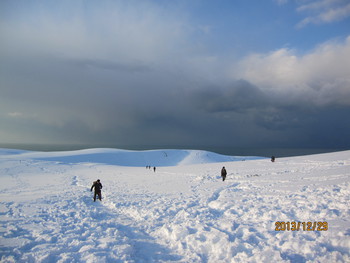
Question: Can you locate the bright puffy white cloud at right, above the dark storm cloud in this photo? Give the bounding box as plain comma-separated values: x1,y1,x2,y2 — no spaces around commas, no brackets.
232,37,350,106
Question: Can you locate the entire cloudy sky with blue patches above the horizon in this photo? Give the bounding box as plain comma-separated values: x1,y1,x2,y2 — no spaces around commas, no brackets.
0,0,350,151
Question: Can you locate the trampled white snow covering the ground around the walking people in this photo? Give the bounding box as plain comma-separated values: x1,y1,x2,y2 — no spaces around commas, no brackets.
0,149,350,262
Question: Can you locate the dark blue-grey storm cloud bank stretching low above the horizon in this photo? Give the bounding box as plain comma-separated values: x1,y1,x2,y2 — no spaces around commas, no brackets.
0,45,350,150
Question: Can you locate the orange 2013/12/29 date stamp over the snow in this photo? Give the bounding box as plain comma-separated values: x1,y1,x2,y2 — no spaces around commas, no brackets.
275,221,328,231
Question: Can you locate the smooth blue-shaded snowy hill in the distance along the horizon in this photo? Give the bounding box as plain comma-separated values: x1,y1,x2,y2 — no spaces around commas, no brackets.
0,149,262,167
